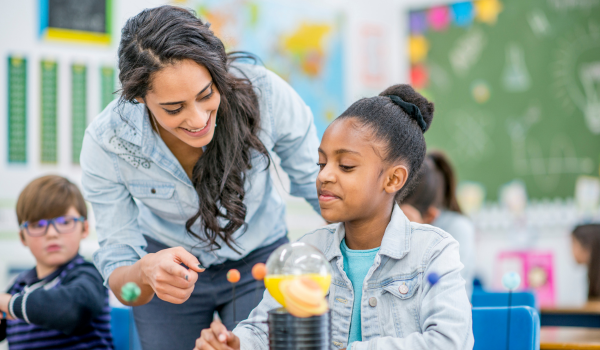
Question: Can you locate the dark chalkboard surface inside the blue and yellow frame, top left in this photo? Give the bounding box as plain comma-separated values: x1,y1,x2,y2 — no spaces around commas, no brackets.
48,0,107,33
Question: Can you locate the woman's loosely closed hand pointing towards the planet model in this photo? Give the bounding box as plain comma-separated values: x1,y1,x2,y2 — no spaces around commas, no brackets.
140,247,204,304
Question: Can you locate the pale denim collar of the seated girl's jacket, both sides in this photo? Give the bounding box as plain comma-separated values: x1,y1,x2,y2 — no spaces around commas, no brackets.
325,204,411,261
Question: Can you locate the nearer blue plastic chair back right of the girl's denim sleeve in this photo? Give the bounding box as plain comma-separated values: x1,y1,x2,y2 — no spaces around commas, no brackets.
473,306,540,350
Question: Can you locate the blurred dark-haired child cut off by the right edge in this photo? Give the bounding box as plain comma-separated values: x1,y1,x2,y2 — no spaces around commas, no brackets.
572,224,600,301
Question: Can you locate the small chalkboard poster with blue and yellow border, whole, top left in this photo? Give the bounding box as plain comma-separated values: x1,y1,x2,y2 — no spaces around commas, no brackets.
39,0,113,45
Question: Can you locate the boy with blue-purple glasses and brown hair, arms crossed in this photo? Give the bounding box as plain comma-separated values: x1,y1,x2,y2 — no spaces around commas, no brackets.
0,175,113,349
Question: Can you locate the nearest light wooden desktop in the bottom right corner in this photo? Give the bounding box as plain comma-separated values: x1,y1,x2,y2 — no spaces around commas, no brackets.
540,327,600,350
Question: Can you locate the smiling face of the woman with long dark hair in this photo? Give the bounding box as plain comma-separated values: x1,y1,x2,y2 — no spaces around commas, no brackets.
137,60,221,148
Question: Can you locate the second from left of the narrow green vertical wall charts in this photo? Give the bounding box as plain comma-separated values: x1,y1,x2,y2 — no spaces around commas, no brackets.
40,60,58,164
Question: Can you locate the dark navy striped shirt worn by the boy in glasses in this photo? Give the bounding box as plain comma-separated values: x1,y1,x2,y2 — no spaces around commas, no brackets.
0,255,113,350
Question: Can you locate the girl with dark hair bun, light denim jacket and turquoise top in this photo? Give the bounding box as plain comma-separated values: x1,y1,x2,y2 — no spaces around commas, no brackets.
196,85,473,350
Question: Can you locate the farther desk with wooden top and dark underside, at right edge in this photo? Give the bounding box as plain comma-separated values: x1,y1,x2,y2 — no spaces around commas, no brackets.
540,301,600,328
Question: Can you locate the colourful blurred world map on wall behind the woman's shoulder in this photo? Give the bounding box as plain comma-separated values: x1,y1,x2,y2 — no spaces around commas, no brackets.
175,0,345,137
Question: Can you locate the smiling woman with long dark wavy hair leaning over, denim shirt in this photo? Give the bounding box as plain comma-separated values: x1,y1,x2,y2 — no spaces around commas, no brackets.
81,6,319,350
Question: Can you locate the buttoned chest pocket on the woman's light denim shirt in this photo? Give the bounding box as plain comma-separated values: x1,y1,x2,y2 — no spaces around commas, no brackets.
127,181,183,220
